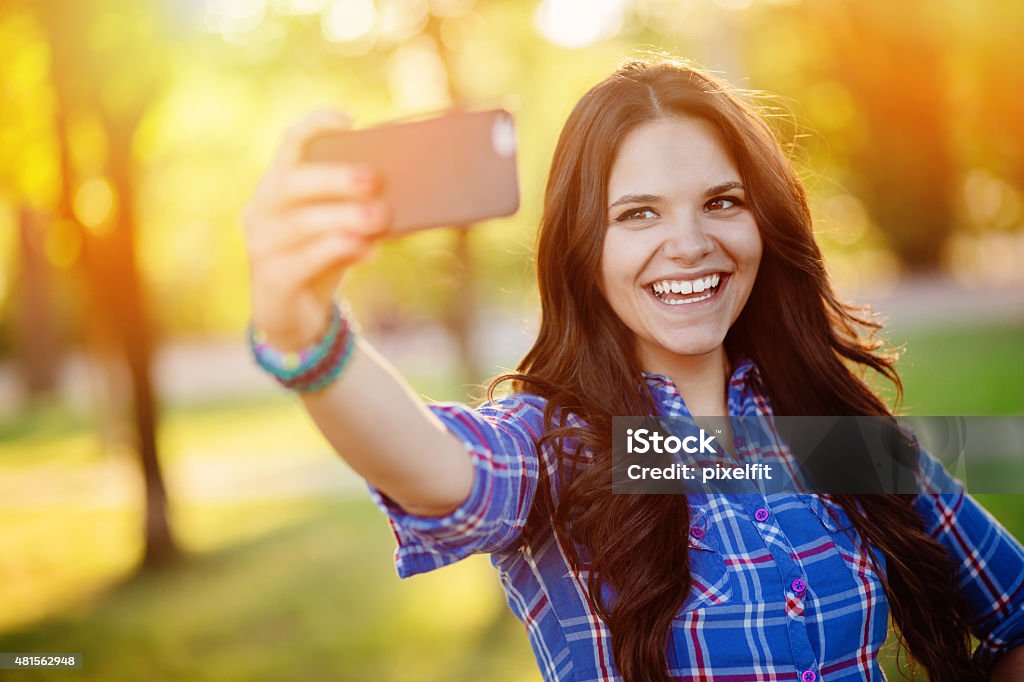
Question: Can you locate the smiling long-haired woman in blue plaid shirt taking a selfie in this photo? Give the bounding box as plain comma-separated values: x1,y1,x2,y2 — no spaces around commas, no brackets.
245,58,1024,682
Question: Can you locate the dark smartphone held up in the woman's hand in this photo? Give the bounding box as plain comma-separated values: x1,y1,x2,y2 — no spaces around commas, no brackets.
305,110,519,233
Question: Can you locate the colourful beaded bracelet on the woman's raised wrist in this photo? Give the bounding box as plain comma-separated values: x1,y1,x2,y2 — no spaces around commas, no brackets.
249,303,355,393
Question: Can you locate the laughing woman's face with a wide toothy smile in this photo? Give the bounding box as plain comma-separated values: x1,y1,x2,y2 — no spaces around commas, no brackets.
601,118,761,372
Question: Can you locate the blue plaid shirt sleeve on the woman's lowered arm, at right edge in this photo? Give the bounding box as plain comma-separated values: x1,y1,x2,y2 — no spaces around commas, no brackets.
916,449,1024,670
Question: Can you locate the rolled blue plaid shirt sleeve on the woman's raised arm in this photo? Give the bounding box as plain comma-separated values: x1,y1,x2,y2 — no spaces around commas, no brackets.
368,396,544,578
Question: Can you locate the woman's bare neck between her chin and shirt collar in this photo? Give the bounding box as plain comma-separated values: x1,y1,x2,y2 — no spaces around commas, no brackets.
641,346,729,417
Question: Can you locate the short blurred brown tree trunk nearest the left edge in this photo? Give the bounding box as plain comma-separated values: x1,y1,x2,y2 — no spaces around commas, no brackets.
14,206,60,402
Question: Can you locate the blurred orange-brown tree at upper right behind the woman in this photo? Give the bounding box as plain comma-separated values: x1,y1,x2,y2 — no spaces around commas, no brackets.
808,0,957,271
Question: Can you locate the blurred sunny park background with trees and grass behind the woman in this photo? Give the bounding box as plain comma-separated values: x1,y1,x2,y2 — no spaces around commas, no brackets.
0,0,1024,682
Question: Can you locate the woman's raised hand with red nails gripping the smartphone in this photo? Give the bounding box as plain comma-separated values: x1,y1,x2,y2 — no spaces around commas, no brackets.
243,111,390,350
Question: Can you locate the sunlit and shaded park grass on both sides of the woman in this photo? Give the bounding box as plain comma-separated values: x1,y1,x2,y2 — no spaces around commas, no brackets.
0,326,1024,682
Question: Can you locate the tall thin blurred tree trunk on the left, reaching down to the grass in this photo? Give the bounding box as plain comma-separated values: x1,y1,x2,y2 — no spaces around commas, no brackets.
36,0,180,567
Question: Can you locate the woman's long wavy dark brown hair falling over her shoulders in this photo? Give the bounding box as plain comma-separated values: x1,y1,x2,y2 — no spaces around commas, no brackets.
488,57,982,682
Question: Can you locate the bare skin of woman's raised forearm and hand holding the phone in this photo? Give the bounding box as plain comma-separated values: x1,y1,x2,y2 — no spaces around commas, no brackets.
243,111,473,516
